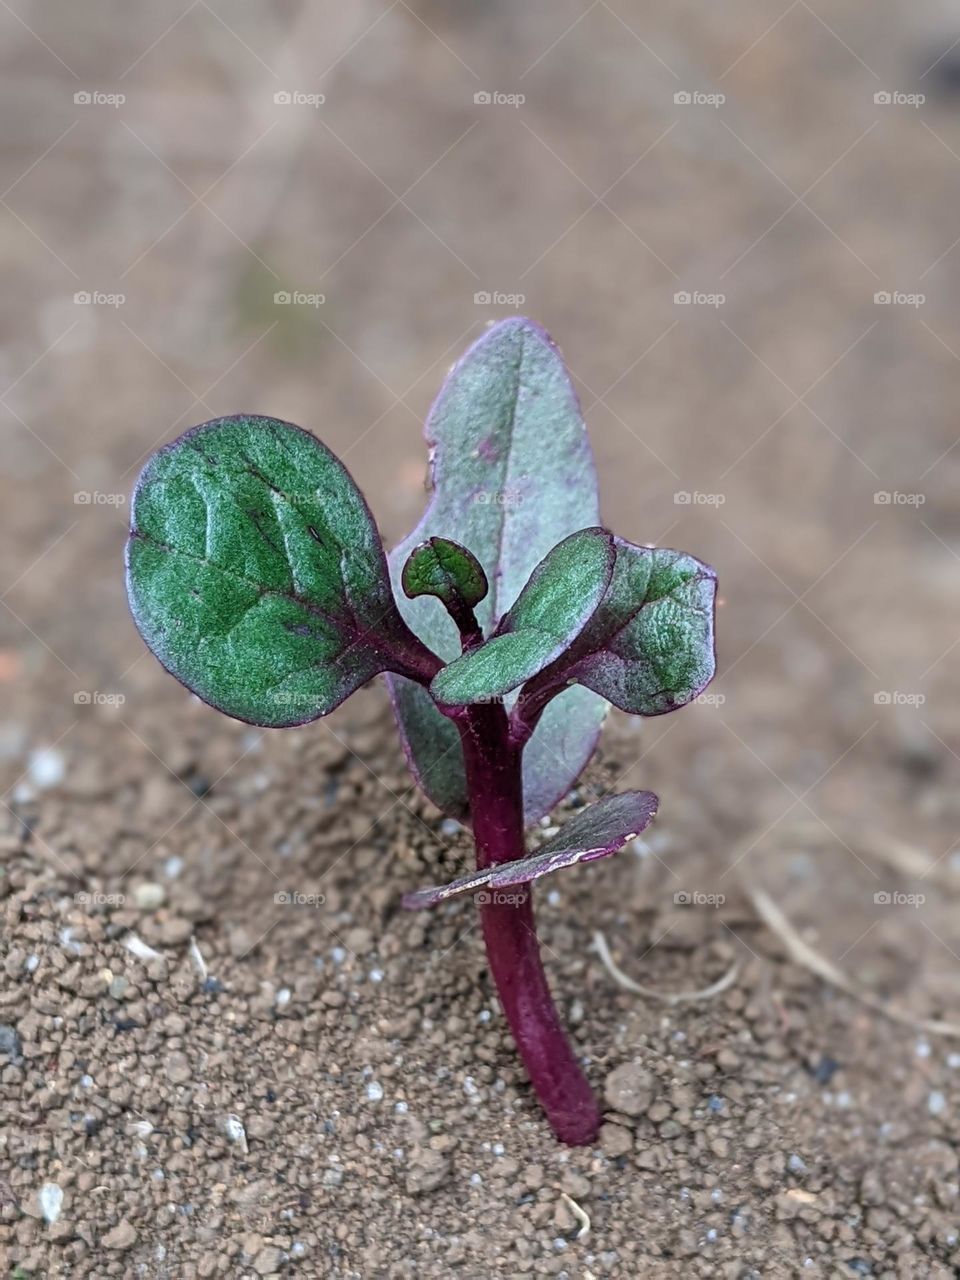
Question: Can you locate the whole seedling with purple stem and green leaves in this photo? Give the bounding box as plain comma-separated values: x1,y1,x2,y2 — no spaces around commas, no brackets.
127,319,717,1144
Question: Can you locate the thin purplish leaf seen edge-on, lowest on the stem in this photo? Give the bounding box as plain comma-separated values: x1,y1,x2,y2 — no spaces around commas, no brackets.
403,791,658,911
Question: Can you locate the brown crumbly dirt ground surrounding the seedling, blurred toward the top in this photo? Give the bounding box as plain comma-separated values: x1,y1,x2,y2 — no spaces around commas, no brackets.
0,0,960,1280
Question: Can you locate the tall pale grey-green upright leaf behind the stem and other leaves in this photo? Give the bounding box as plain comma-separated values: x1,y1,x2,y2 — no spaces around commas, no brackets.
387,317,607,823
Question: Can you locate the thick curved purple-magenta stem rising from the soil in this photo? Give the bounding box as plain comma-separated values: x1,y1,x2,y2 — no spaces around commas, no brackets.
457,704,600,1147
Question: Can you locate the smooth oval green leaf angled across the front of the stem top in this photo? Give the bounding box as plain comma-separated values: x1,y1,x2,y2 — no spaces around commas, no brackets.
430,529,614,707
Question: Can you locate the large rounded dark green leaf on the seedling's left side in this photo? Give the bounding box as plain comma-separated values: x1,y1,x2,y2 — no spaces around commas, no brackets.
127,416,436,726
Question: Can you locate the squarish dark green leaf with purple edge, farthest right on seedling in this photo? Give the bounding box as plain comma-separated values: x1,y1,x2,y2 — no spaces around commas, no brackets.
524,538,717,716
